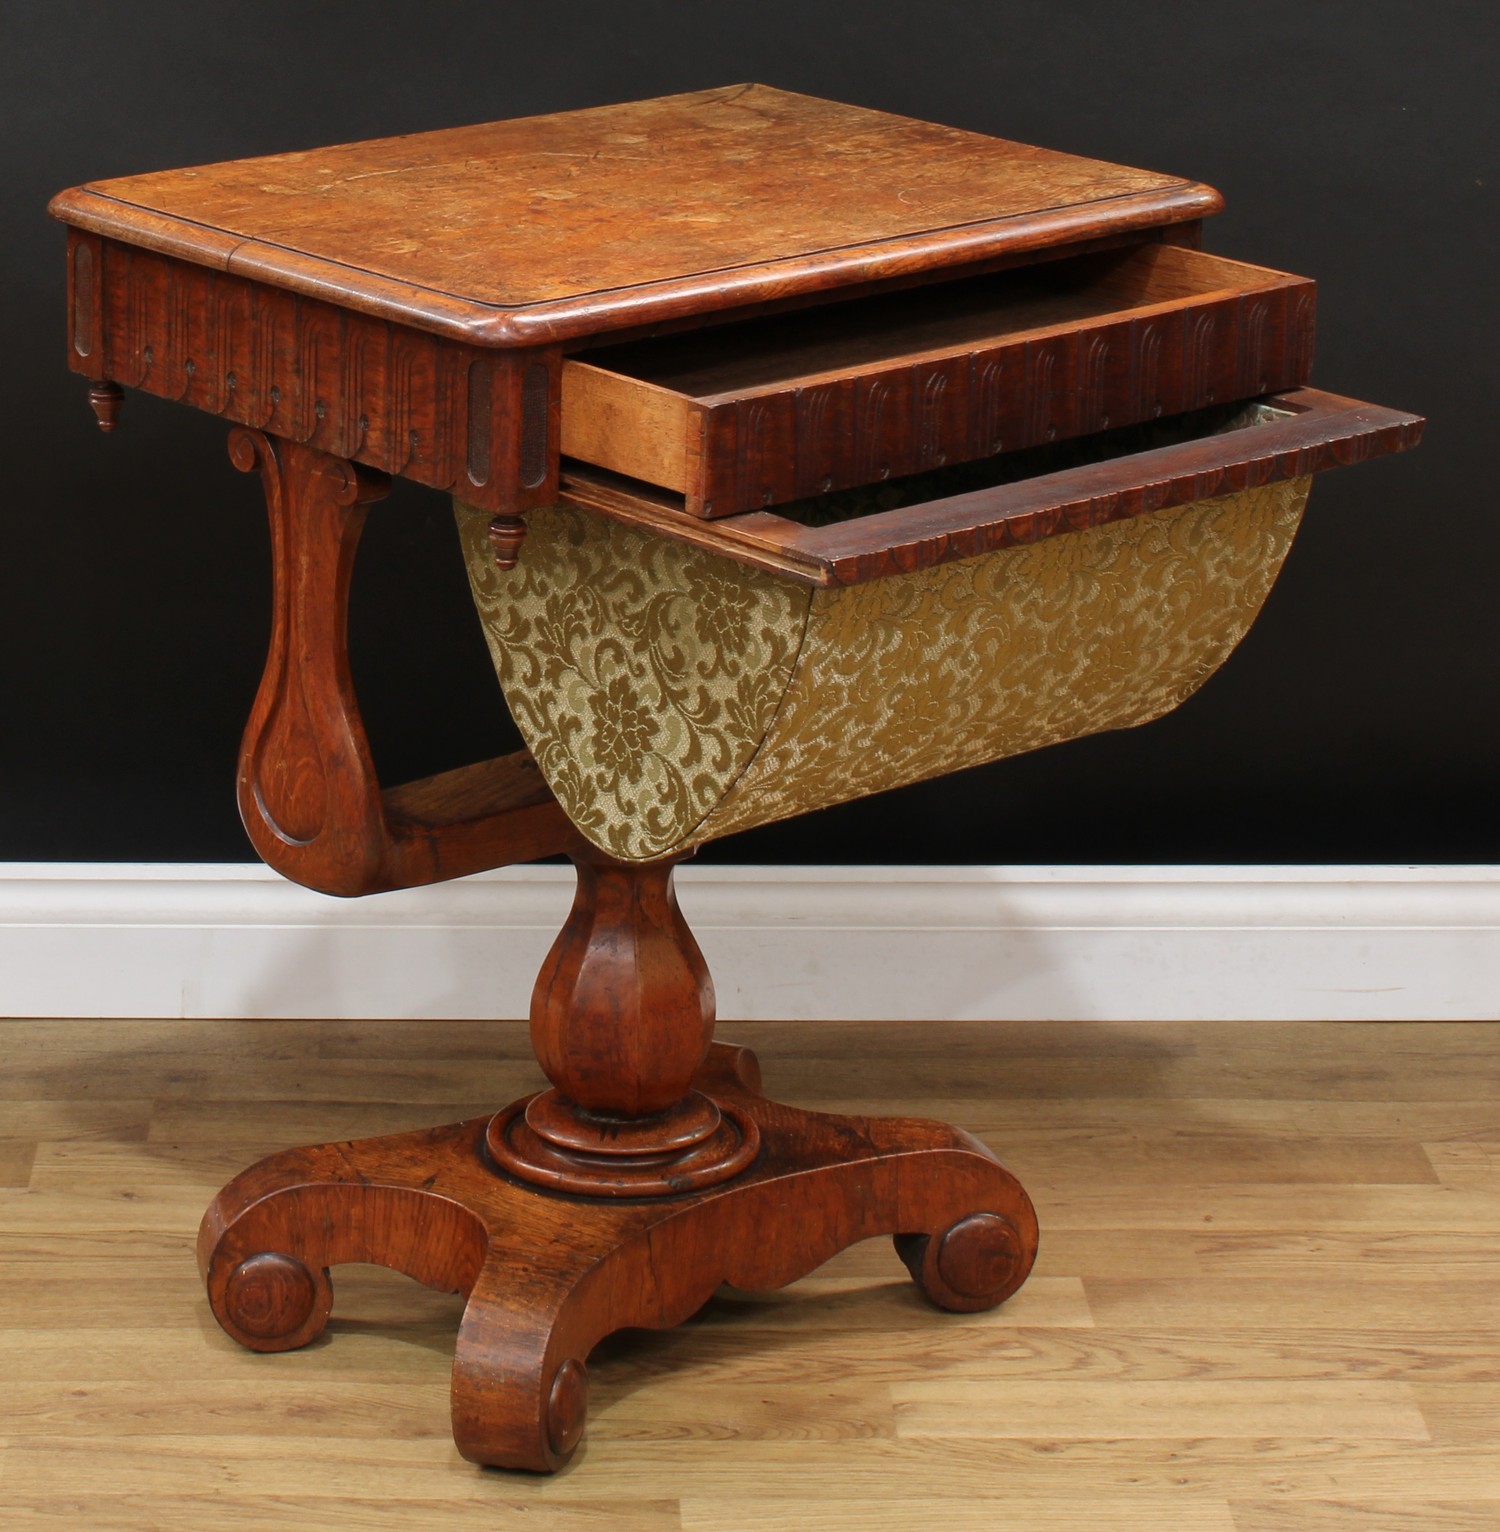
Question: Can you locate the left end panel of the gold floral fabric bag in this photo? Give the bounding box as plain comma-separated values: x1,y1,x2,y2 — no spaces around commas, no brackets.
457,504,811,859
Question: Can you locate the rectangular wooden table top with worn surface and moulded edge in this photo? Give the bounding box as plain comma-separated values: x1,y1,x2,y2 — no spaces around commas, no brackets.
52,84,1220,346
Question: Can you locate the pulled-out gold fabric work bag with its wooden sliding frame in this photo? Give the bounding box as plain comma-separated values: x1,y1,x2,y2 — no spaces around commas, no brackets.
458,391,1417,861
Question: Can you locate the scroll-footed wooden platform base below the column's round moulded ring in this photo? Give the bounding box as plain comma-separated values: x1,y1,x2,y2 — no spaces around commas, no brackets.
198,1043,1037,1471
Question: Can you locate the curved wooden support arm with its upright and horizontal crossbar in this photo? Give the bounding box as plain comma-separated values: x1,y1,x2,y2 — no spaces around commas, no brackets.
230,427,582,895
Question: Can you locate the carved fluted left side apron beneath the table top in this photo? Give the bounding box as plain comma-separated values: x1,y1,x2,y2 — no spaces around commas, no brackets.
58,230,562,513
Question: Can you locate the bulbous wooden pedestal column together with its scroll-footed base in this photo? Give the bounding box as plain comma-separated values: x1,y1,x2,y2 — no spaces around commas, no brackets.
199,856,1037,1471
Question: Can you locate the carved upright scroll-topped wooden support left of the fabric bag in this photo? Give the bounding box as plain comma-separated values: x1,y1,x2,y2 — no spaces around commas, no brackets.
230,427,389,895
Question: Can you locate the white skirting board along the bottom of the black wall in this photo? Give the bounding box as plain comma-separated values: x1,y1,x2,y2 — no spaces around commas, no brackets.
0,863,1500,1020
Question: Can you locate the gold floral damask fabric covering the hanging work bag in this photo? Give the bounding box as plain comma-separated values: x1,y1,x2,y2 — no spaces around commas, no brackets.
457,478,1310,861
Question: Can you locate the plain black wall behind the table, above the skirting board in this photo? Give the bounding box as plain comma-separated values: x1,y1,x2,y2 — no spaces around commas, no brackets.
0,0,1500,863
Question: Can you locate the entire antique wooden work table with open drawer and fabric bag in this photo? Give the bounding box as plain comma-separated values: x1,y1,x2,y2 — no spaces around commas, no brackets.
52,86,1420,1469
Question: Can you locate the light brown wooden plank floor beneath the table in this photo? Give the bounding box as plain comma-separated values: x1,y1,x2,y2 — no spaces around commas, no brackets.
0,1022,1500,1532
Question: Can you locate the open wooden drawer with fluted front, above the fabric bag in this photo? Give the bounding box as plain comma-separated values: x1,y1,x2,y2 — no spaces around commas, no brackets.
562,242,1315,518
